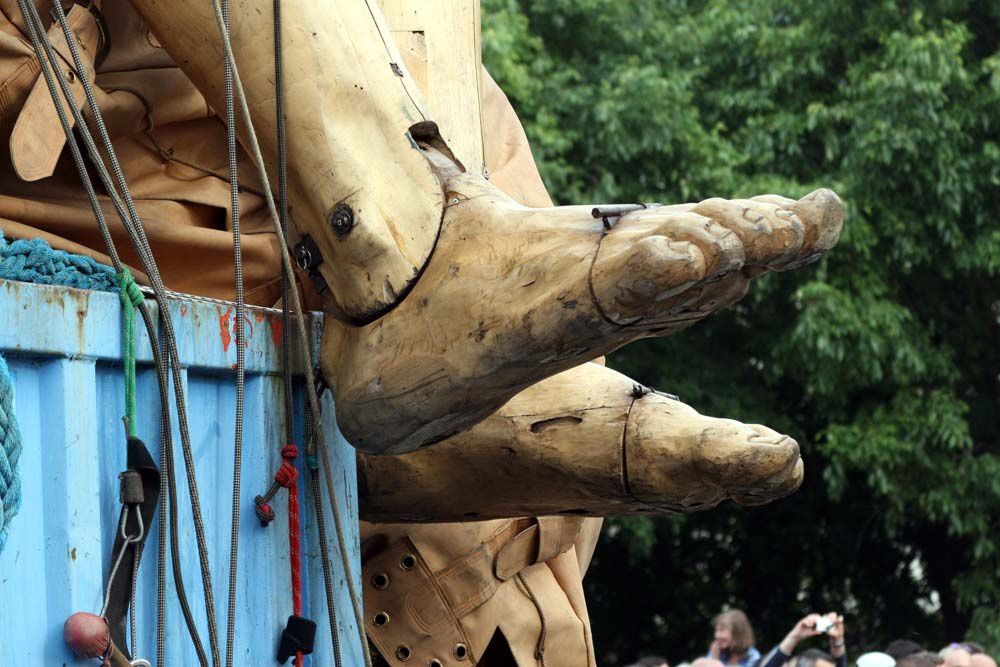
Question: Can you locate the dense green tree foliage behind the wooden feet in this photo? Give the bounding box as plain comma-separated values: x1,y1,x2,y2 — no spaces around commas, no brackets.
483,0,1000,664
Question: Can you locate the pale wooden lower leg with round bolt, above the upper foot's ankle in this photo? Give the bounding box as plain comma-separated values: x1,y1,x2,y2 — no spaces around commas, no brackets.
132,0,444,321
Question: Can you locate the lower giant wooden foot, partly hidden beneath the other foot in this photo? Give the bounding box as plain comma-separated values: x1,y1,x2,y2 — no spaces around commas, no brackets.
358,364,803,522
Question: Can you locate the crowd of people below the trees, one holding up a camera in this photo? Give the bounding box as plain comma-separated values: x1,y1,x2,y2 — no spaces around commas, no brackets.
627,609,997,667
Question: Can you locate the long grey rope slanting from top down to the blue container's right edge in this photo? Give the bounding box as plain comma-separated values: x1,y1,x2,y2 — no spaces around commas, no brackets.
212,0,372,667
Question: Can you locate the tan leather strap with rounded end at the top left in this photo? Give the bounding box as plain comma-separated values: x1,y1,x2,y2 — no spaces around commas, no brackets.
10,4,101,181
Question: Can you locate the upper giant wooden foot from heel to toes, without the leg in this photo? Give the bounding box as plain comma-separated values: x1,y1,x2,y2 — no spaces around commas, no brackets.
323,160,843,453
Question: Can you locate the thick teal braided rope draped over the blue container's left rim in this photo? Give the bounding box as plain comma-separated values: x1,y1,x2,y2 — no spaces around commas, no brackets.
0,230,119,552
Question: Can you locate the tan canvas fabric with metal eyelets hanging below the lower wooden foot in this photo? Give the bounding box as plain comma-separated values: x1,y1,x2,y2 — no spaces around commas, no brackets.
362,517,601,667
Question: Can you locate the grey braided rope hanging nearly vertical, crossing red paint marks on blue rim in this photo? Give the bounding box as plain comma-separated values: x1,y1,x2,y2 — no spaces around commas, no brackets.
222,0,248,667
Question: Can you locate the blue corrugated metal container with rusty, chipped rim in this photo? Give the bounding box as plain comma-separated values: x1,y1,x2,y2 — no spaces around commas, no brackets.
0,280,362,666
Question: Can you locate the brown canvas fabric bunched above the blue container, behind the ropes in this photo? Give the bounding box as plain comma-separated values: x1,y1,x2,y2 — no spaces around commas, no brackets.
0,0,280,305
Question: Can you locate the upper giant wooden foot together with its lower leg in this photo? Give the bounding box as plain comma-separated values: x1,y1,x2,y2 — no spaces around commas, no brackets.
133,0,842,453
